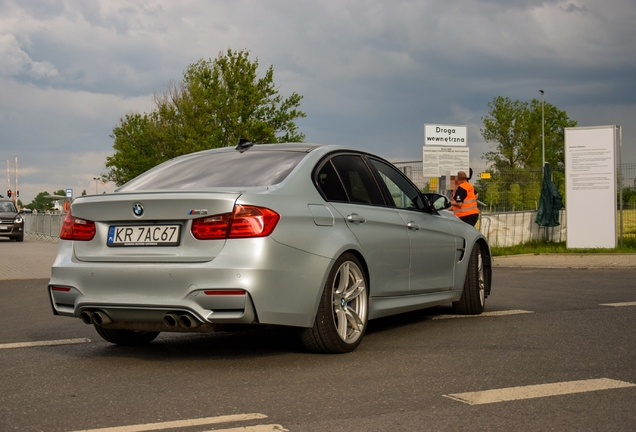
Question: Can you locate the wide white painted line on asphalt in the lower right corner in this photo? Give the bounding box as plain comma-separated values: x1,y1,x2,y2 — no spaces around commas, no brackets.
443,378,636,405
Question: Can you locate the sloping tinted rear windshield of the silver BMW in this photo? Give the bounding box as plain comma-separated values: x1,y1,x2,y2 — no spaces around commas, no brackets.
118,150,307,192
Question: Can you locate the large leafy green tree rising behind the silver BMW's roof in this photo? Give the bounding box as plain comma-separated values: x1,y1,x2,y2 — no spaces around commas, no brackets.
105,50,306,186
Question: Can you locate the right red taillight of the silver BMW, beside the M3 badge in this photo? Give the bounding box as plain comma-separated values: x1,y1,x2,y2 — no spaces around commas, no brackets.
191,205,280,240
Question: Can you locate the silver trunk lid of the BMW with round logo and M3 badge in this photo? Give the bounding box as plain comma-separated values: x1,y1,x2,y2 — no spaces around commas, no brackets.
71,192,241,262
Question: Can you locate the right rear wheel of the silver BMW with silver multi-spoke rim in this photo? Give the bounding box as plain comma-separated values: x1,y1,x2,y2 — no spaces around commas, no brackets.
300,253,369,354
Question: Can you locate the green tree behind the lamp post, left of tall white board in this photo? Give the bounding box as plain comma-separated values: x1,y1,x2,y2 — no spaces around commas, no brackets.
481,96,577,171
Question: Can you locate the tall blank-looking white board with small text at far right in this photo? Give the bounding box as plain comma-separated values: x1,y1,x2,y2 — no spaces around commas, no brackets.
565,126,617,248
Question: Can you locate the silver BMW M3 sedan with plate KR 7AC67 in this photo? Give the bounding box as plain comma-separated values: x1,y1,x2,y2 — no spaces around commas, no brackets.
48,143,492,353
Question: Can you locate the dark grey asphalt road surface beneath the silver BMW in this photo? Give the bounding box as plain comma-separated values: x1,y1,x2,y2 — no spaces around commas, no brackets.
0,239,636,432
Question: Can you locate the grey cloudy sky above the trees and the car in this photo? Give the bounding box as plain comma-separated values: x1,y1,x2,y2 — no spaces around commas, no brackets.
0,0,636,204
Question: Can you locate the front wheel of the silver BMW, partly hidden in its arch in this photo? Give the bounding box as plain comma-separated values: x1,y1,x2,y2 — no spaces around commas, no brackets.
453,243,486,315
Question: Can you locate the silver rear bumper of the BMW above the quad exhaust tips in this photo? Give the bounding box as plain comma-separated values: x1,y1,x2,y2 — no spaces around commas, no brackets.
48,237,332,331
